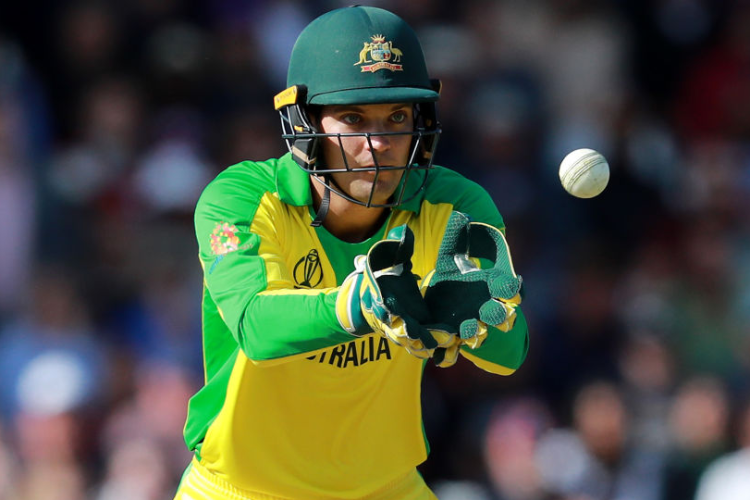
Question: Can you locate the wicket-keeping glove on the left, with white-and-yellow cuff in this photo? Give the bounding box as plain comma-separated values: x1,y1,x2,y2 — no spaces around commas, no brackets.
336,224,454,359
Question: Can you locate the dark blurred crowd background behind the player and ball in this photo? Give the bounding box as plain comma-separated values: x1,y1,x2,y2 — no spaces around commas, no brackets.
0,0,750,500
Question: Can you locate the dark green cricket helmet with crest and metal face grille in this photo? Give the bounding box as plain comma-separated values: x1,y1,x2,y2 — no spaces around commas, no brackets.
274,6,440,219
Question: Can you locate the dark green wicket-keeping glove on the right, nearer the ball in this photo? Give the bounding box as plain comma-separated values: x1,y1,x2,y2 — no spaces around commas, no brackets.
422,212,522,357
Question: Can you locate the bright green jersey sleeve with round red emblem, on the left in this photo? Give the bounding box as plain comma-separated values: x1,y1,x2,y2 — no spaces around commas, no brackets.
195,164,352,362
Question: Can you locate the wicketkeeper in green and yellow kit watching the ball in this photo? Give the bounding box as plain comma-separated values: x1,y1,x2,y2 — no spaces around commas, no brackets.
175,6,528,500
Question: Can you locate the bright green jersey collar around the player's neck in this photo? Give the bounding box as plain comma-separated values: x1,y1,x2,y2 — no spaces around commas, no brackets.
276,153,427,213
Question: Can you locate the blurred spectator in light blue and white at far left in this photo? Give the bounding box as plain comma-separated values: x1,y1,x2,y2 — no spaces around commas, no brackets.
0,268,107,420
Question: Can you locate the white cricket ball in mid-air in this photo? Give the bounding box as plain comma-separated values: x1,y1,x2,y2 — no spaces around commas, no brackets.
560,148,609,198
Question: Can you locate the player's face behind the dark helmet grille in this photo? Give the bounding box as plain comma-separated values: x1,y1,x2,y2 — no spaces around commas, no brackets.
320,103,414,204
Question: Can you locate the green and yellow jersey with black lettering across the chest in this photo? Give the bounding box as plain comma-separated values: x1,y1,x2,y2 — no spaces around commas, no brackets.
185,154,528,499
